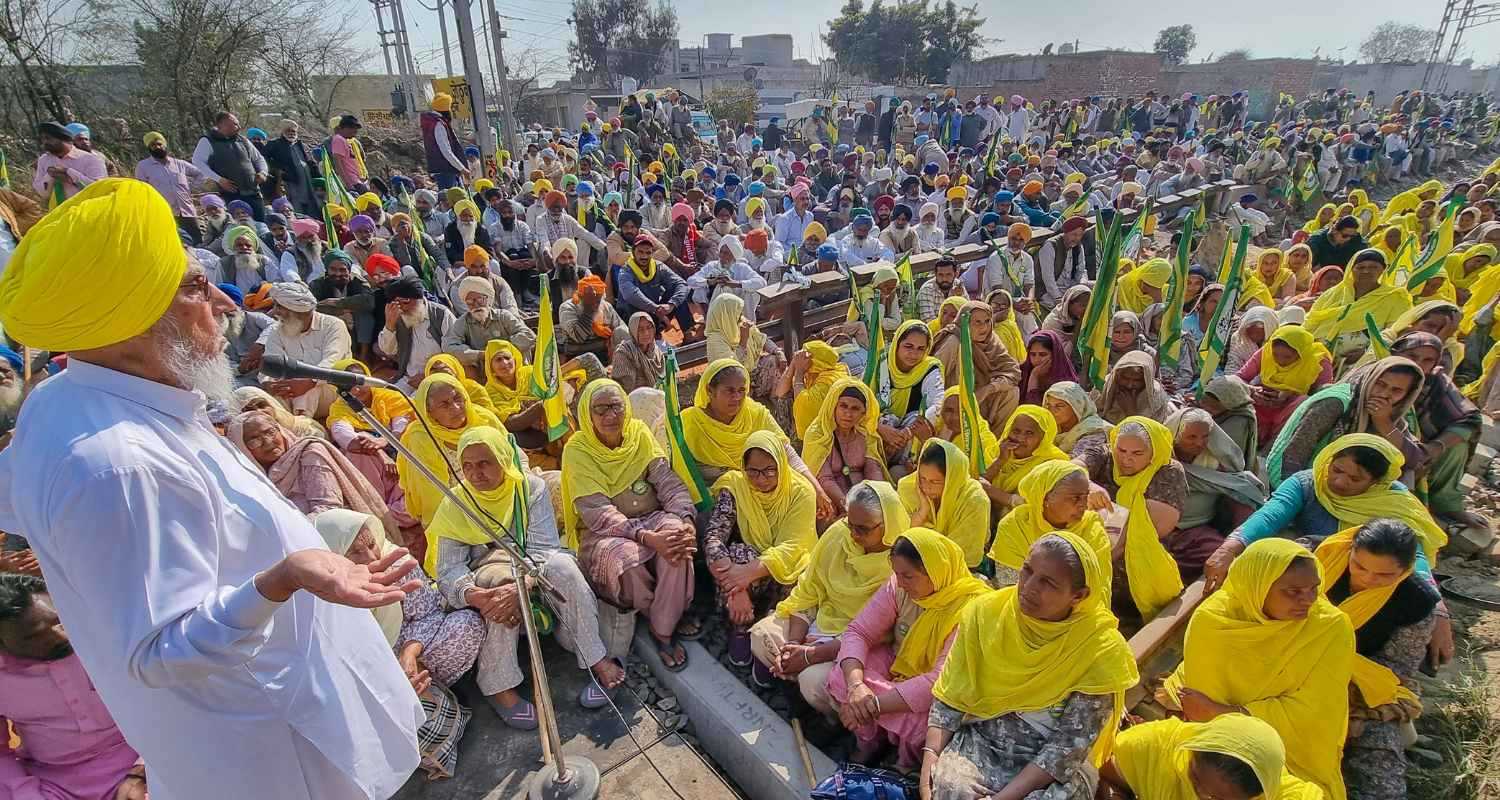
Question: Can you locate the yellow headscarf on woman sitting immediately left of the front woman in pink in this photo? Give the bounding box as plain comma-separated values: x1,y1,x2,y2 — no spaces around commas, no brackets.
776,480,912,635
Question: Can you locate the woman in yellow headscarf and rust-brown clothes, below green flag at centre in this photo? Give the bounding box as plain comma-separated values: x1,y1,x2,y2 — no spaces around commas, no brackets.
803,378,891,516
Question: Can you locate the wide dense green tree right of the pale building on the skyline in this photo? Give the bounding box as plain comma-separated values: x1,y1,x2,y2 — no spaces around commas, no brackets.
824,0,984,83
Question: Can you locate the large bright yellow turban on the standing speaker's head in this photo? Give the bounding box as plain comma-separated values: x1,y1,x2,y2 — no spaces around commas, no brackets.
0,179,188,351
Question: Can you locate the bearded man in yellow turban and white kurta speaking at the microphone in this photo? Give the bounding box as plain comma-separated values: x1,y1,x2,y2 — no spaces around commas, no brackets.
0,179,423,800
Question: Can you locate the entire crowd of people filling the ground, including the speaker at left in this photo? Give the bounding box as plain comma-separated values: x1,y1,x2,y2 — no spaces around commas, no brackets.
0,81,1500,800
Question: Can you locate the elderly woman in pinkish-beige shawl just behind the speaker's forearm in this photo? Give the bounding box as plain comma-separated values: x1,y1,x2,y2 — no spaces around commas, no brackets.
228,411,396,530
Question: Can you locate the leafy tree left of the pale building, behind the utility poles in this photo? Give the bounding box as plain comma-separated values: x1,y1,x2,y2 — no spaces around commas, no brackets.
567,0,677,84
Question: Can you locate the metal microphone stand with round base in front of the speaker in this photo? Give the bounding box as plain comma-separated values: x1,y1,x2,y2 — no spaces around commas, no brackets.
339,387,600,800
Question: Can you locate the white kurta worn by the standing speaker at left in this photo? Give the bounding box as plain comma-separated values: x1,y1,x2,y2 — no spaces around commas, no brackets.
0,360,423,800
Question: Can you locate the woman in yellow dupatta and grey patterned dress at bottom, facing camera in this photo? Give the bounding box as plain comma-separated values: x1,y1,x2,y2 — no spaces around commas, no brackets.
920,531,1139,800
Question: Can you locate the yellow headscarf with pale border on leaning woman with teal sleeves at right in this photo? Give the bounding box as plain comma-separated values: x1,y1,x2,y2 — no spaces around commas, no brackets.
1313,434,1448,561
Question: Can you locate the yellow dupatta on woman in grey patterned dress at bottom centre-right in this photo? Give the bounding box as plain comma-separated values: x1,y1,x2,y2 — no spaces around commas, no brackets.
933,531,1140,765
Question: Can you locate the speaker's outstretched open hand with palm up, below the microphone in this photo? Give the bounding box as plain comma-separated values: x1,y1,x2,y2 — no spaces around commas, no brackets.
255,548,422,608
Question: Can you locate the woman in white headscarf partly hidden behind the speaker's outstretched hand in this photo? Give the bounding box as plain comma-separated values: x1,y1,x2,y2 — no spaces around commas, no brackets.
314,509,485,780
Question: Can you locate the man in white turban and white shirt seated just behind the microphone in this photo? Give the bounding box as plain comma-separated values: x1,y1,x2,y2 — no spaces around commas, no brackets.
261,282,354,417
